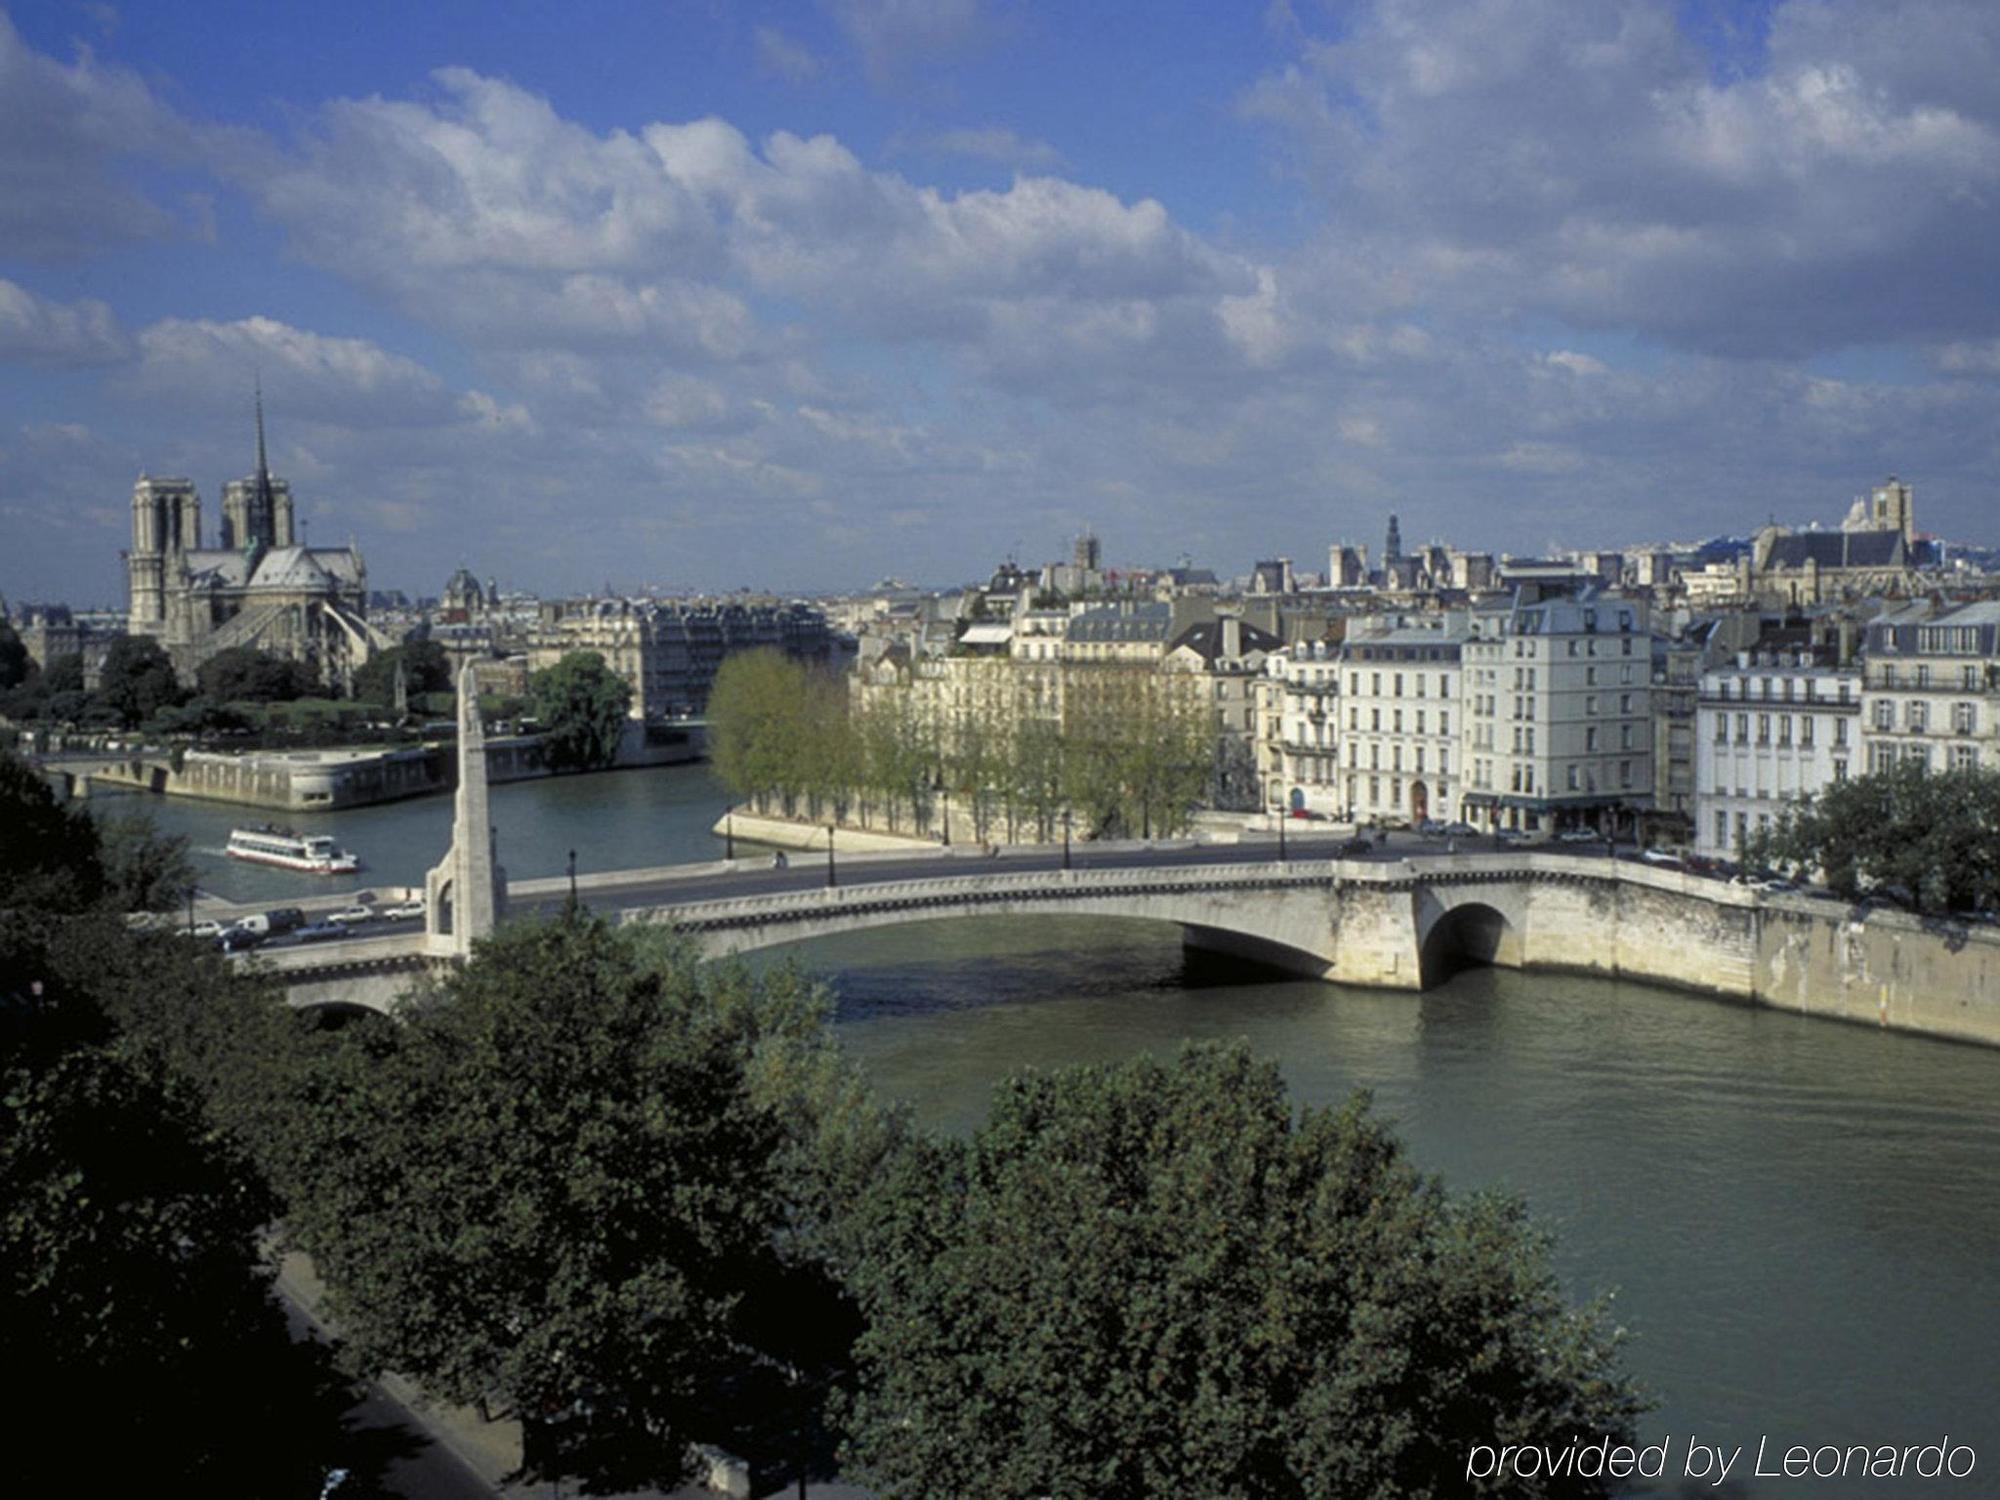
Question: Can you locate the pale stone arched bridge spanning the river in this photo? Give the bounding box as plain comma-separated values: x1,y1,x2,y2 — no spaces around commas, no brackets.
258,852,1760,1010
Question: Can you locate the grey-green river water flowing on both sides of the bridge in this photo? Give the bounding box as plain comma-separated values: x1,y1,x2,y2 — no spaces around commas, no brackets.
94,766,2000,1496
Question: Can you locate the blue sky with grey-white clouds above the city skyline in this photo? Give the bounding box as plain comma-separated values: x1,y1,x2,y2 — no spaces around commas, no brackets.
0,0,2000,604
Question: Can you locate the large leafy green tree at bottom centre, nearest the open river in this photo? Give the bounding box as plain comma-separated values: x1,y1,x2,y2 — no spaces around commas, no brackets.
850,1048,1640,1500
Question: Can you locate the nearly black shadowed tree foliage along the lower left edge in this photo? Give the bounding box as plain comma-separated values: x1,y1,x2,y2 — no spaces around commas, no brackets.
0,756,352,1498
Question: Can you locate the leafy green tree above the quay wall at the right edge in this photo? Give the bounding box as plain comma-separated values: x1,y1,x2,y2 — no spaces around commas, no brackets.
1744,760,2000,914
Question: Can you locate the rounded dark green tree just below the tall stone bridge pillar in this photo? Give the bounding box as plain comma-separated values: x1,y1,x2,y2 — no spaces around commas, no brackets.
288,914,888,1486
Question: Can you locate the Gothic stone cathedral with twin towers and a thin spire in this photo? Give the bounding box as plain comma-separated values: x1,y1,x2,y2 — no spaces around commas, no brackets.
126,398,390,690
